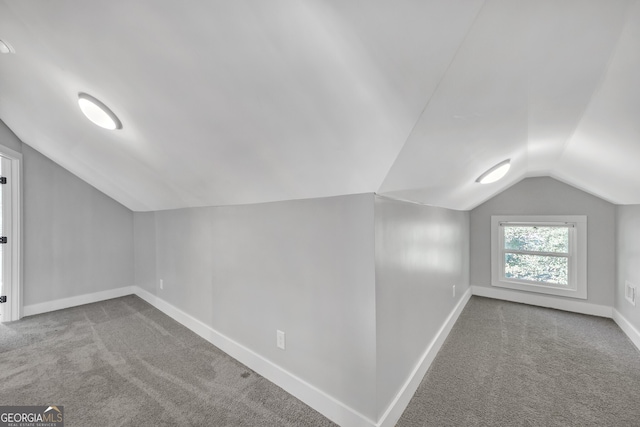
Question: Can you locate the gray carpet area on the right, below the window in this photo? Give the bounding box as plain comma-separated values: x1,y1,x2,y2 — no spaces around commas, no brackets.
397,297,640,427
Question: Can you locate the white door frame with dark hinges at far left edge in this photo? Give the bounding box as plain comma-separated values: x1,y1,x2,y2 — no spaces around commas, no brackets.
0,145,22,322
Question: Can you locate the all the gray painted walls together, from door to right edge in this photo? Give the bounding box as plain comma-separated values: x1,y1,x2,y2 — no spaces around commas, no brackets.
7,113,640,420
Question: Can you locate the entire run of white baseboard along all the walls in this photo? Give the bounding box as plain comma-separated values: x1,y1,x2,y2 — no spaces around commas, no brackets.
24,285,640,427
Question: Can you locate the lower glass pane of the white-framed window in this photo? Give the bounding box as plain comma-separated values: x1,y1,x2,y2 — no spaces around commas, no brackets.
504,253,569,286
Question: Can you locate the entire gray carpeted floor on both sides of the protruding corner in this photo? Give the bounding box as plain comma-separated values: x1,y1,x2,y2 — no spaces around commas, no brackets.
0,296,640,427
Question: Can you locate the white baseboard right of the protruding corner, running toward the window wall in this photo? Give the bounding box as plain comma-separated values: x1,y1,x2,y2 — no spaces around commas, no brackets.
377,287,472,427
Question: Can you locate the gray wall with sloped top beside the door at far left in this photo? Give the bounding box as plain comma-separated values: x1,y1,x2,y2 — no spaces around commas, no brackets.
0,122,134,305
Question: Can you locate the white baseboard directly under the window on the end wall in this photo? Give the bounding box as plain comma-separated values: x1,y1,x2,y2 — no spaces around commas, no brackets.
471,285,613,318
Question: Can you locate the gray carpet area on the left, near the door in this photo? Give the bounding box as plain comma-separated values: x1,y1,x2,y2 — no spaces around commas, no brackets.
0,296,335,427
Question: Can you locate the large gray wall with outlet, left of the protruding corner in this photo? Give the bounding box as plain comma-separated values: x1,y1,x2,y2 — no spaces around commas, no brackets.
135,194,376,419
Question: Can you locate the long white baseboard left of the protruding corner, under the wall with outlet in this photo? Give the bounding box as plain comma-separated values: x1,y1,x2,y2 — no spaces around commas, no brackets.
134,287,376,427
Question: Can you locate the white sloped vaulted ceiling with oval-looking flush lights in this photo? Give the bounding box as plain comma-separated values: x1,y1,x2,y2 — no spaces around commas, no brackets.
0,0,640,211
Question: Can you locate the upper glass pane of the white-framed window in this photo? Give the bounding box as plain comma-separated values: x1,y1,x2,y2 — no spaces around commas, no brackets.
504,225,569,254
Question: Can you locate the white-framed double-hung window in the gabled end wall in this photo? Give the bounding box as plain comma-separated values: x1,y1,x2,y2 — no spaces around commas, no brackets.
491,215,587,299
